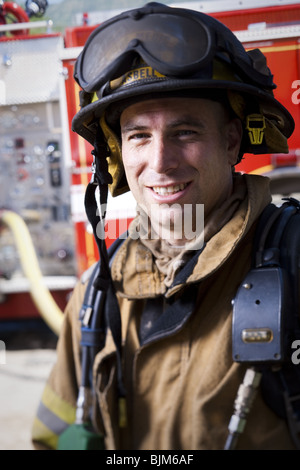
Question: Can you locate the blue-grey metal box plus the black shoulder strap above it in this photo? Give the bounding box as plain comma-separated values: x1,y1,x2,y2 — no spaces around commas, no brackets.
233,199,300,364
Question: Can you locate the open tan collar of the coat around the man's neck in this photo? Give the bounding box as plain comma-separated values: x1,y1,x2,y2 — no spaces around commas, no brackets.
112,175,271,299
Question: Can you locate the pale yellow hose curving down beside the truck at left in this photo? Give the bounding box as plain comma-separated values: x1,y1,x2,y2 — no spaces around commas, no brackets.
0,210,63,335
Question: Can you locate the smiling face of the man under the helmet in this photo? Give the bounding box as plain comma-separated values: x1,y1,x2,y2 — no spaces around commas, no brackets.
120,98,241,244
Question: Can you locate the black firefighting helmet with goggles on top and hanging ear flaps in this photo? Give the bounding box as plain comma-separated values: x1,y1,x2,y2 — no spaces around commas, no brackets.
72,3,294,196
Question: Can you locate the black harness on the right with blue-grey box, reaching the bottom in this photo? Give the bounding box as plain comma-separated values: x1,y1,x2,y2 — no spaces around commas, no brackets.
227,198,300,449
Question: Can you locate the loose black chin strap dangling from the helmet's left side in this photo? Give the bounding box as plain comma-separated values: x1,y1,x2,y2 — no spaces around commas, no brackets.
85,126,125,397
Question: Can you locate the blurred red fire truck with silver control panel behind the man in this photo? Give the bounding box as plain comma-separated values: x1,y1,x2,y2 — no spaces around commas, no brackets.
0,0,300,332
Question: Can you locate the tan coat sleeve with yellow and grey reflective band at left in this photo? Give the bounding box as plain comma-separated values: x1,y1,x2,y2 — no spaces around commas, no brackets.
32,281,85,449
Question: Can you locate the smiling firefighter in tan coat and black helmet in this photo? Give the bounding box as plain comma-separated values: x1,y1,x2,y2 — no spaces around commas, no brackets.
33,3,295,450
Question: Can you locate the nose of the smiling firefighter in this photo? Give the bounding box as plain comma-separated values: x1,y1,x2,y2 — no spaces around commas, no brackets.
149,137,180,173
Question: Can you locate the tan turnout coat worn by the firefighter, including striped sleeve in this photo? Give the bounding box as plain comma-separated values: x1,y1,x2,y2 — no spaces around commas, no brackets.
33,175,293,450
